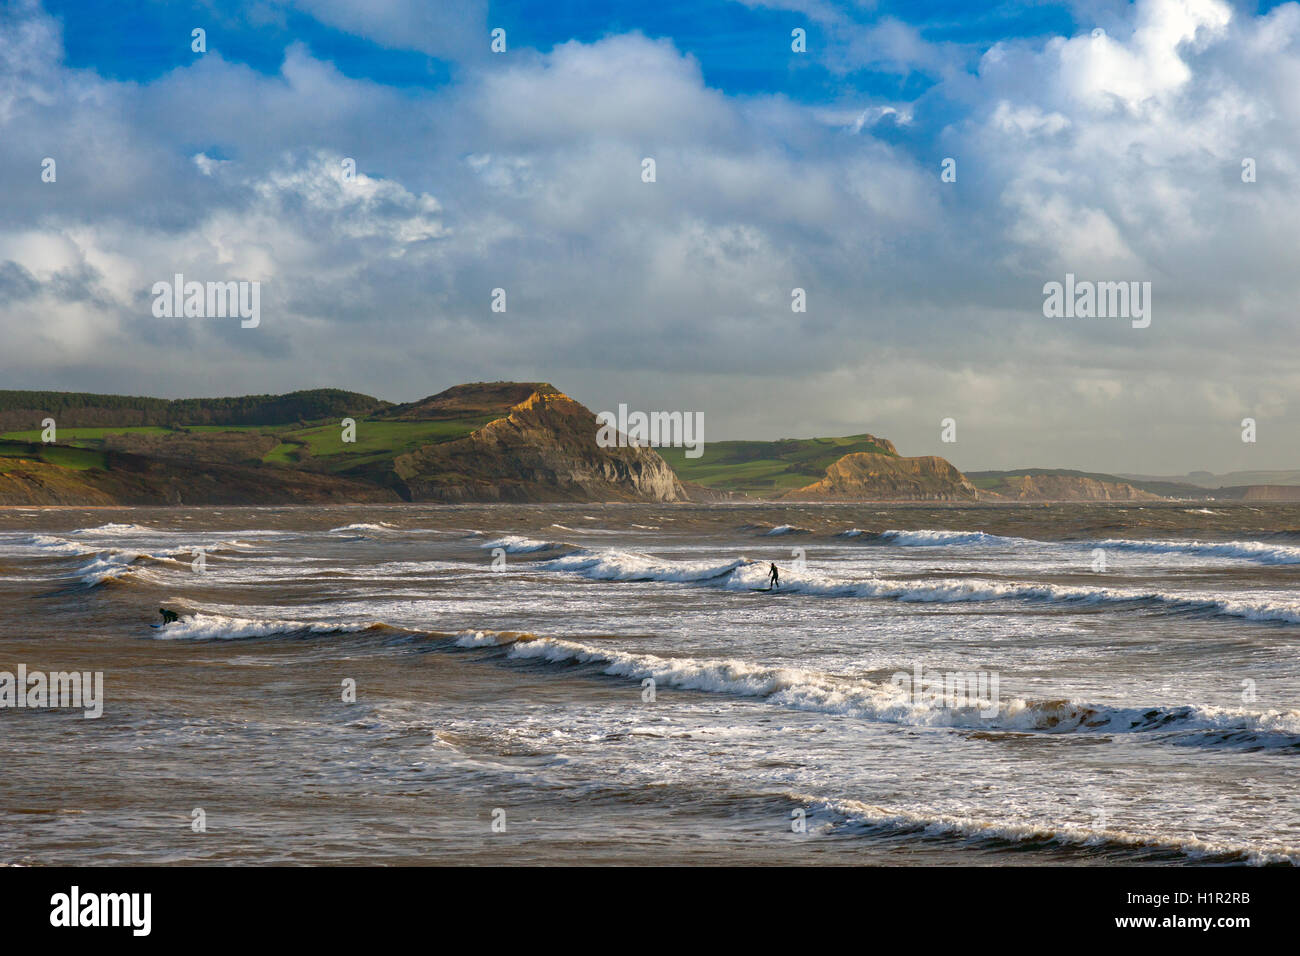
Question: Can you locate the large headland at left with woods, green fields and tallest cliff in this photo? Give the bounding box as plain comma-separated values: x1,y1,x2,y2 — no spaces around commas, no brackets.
0,382,686,505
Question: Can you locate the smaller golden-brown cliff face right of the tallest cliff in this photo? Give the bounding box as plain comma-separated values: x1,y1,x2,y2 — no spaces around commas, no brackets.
781,451,979,501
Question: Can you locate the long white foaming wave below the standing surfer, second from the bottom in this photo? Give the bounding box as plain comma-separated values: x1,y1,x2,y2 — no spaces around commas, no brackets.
456,631,1300,752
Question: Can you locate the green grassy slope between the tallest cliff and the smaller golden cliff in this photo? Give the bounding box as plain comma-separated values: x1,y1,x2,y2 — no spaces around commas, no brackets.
655,434,898,497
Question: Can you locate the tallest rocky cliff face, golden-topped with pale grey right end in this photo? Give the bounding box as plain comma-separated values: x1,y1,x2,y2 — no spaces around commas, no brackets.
394,386,688,502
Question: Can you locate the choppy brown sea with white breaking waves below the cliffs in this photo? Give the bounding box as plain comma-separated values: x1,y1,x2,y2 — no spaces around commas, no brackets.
0,502,1300,866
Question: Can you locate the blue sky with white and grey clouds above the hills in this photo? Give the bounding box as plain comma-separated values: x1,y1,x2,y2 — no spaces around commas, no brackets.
0,0,1300,475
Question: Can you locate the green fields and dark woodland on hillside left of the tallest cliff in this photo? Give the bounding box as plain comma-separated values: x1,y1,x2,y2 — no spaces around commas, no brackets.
0,382,538,499
